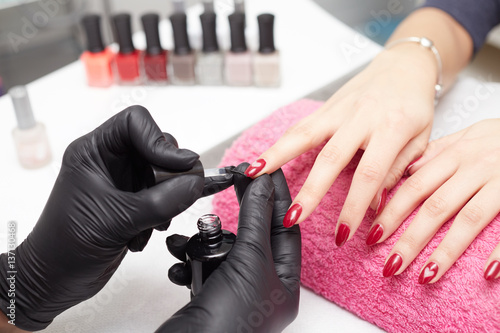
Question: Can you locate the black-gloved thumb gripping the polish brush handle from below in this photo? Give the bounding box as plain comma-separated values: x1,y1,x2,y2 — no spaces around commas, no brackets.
131,175,205,231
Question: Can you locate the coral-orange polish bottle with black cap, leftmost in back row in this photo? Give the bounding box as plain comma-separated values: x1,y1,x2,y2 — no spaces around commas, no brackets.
80,15,114,87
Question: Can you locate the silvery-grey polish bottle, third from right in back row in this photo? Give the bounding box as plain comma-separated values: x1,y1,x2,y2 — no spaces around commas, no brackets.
196,11,224,85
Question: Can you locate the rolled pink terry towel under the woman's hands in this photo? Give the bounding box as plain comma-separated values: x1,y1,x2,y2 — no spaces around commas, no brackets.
213,100,500,332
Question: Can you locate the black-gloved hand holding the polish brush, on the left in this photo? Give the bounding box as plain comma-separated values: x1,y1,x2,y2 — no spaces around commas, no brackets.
0,106,223,330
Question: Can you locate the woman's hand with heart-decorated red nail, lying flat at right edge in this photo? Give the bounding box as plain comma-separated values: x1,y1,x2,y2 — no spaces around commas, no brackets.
370,119,500,284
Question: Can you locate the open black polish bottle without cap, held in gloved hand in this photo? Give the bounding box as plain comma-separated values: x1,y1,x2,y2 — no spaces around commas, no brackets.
186,214,236,296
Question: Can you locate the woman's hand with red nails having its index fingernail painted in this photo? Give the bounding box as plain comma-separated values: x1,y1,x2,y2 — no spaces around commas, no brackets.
246,43,437,246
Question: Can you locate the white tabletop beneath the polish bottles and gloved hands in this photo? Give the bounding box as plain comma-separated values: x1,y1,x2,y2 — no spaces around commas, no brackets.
0,0,388,333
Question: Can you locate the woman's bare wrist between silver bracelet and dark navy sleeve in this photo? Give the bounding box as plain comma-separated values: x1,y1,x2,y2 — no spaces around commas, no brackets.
388,8,473,88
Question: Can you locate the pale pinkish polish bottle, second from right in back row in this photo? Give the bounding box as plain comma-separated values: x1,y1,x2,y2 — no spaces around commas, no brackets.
225,13,253,86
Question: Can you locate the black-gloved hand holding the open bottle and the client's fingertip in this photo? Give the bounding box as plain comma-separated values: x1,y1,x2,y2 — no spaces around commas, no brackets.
158,164,301,333
